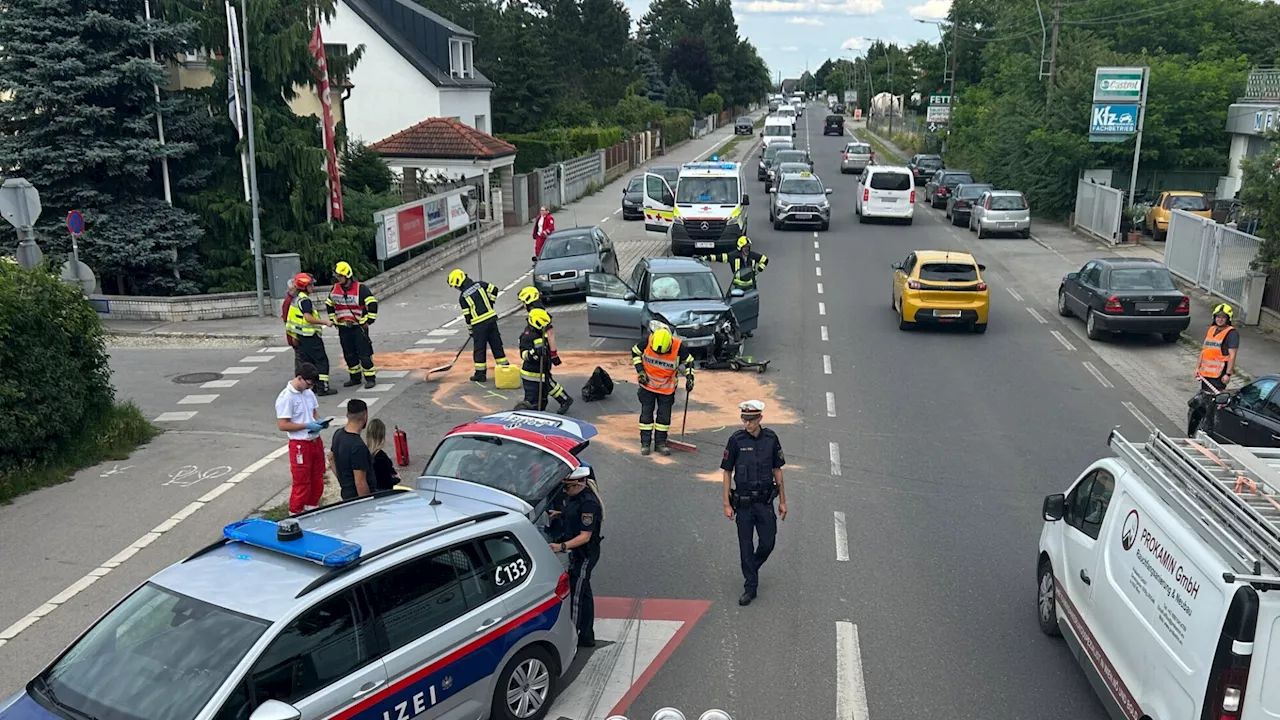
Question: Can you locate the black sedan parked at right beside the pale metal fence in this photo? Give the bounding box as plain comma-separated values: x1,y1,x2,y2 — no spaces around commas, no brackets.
1057,258,1192,342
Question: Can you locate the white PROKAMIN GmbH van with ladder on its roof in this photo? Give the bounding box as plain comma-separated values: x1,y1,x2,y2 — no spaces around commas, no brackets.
1037,430,1280,720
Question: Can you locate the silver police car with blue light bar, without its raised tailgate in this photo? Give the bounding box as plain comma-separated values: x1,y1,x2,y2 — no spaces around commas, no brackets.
0,478,577,720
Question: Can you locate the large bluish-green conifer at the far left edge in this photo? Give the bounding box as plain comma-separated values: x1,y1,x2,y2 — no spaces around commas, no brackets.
0,0,201,293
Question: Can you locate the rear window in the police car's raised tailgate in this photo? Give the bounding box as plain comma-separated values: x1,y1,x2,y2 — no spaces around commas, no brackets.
422,436,570,506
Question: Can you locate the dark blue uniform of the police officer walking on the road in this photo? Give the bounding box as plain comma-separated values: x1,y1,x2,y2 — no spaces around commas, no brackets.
721,428,787,597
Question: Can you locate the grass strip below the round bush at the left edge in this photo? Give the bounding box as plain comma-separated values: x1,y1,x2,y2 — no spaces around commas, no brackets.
0,402,160,503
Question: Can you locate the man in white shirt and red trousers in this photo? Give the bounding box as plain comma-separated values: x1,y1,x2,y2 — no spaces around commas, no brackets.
275,363,325,515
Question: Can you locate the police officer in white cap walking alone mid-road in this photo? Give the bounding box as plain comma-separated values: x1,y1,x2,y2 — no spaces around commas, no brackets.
721,400,787,605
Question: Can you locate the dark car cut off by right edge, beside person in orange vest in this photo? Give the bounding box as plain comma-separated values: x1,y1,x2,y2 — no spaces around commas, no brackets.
1187,375,1280,447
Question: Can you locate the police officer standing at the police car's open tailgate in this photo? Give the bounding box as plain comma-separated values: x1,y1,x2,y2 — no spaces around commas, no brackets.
549,466,604,647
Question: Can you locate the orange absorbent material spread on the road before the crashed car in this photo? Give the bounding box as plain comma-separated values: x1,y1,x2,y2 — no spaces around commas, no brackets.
374,350,797,466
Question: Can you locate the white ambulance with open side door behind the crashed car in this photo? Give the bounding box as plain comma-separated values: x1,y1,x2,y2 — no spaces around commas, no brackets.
644,156,750,255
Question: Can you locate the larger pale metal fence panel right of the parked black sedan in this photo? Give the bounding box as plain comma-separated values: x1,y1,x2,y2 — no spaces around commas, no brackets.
1165,210,1262,305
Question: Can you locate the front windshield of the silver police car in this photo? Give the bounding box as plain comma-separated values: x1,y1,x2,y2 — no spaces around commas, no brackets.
36,583,268,720
